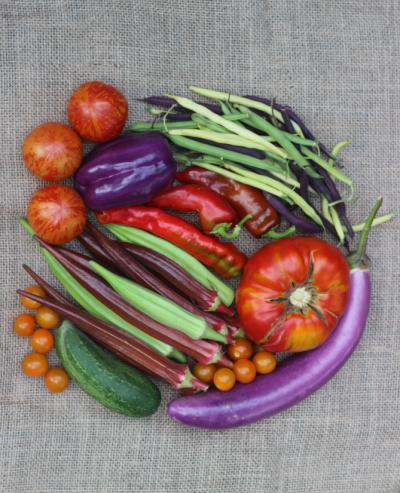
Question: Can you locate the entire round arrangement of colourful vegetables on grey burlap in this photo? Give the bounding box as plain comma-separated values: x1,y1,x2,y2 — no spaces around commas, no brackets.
14,81,393,429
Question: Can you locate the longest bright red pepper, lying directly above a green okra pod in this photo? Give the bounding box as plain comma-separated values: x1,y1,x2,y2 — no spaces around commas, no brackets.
96,206,247,277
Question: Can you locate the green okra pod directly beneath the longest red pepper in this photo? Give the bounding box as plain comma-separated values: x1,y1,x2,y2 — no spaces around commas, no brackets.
104,224,235,306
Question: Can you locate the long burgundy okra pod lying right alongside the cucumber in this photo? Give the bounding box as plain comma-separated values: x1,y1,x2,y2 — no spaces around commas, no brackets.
17,289,207,390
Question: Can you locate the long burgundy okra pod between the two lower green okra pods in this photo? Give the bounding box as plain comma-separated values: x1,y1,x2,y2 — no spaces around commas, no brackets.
28,240,231,366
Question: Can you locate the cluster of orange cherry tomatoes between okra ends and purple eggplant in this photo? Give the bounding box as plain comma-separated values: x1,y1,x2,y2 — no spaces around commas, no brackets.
193,338,276,392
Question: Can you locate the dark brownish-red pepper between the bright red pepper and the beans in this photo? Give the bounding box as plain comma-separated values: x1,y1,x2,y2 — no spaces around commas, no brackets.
176,167,280,236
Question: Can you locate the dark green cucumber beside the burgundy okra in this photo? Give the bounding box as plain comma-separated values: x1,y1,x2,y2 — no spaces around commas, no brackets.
55,320,161,417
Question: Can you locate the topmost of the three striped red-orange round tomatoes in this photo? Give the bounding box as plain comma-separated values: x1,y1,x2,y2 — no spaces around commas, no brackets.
68,81,128,142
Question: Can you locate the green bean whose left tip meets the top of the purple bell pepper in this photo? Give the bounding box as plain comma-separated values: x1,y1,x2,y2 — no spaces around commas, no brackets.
168,135,298,186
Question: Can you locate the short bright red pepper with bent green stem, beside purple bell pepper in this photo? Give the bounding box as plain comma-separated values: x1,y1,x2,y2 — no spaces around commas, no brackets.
148,184,244,239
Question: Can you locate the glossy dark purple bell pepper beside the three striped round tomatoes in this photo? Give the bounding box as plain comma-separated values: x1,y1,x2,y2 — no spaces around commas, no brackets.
75,132,176,211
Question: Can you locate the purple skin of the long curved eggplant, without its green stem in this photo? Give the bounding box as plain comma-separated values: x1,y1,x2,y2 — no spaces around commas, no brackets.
168,267,371,429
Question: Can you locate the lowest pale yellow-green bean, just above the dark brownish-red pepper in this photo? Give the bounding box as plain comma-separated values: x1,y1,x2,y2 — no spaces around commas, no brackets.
186,160,323,227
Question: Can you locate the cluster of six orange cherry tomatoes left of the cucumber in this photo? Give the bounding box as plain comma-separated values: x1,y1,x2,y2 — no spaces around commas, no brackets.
14,286,69,393
